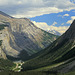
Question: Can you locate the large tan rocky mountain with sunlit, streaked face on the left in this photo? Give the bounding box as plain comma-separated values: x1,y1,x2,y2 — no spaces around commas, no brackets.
0,11,58,60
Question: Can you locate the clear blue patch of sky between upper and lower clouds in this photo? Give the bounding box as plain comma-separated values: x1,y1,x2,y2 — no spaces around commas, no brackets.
30,9,75,27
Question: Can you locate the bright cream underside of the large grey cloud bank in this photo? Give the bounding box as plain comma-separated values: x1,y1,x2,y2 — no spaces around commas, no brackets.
12,7,62,18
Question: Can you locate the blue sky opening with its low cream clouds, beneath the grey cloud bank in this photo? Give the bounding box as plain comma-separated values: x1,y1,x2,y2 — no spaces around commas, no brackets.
30,9,75,34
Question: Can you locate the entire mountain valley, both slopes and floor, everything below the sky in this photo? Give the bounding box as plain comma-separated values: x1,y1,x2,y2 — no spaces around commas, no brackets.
0,11,75,75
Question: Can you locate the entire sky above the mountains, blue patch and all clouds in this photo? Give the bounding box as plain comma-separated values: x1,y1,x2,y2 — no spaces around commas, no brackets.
0,0,75,34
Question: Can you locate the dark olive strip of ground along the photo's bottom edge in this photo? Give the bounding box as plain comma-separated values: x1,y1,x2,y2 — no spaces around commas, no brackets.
0,71,75,75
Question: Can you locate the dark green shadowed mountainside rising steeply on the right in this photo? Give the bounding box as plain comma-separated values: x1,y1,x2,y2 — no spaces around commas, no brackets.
22,20,75,75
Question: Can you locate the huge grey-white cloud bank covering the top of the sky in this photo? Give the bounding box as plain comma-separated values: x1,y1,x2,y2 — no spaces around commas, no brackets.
0,0,75,17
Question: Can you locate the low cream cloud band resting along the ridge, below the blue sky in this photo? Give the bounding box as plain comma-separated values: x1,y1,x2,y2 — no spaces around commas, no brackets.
32,21,69,34
